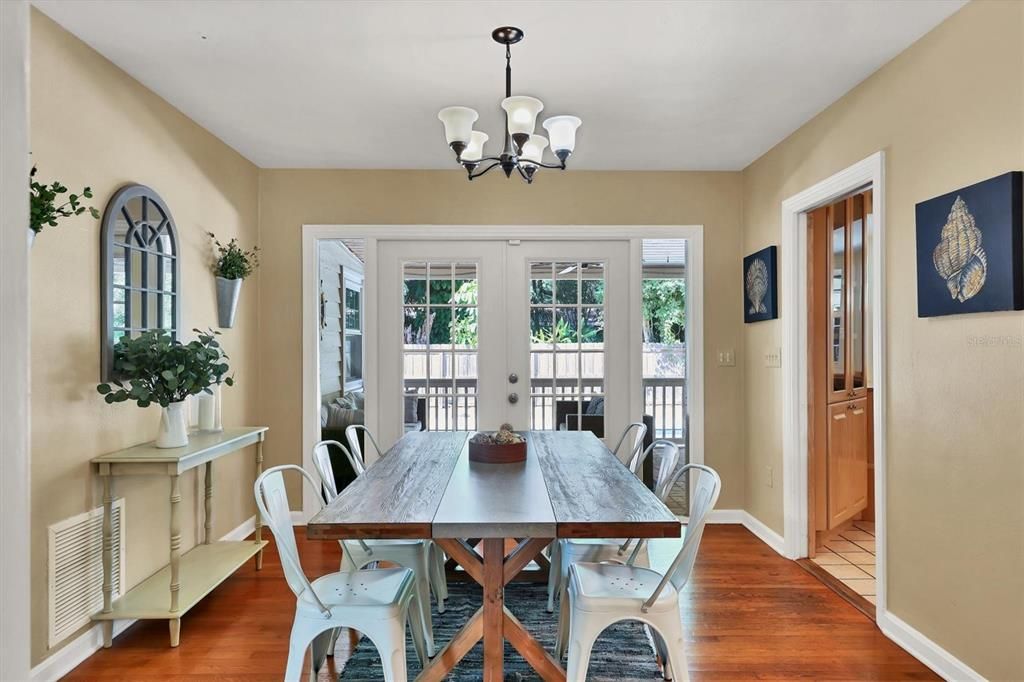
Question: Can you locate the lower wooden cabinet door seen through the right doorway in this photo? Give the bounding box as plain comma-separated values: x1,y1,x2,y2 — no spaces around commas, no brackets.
827,397,870,528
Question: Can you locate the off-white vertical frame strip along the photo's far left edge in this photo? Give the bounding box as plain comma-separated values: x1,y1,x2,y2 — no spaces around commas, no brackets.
0,0,32,680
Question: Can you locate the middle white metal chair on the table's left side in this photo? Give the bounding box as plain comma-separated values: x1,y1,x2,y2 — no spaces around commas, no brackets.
313,438,447,656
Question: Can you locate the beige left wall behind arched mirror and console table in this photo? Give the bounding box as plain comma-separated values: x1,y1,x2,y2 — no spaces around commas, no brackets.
31,11,260,664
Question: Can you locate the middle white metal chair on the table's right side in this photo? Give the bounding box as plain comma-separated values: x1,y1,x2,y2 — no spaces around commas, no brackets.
548,440,679,613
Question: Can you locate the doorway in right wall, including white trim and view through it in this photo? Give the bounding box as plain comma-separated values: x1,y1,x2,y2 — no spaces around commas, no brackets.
779,152,891,630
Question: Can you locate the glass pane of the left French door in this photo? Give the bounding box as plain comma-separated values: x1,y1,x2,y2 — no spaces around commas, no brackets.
402,262,479,431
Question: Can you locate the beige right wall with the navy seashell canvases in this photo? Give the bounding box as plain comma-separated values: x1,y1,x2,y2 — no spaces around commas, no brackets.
743,0,1024,680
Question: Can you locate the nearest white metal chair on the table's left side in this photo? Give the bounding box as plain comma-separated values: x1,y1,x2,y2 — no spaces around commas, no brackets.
253,464,427,682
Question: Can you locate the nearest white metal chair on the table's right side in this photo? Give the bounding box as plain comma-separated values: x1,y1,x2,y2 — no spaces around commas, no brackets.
555,464,722,682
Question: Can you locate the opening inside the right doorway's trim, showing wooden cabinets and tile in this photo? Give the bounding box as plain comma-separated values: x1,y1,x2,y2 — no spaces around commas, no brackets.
805,187,877,616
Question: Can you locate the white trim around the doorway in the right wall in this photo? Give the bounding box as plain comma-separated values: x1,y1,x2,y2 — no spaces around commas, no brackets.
781,152,887,619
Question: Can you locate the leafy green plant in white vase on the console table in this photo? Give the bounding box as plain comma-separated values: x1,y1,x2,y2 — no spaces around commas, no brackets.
96,329,233,447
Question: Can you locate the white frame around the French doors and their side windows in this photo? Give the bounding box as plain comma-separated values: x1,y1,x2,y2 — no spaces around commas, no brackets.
302,224,705,520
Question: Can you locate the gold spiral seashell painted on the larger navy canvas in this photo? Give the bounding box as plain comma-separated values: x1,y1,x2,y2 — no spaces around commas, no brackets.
932,196,988,303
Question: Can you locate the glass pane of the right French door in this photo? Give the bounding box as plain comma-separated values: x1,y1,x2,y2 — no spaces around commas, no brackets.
529,261,605,437
